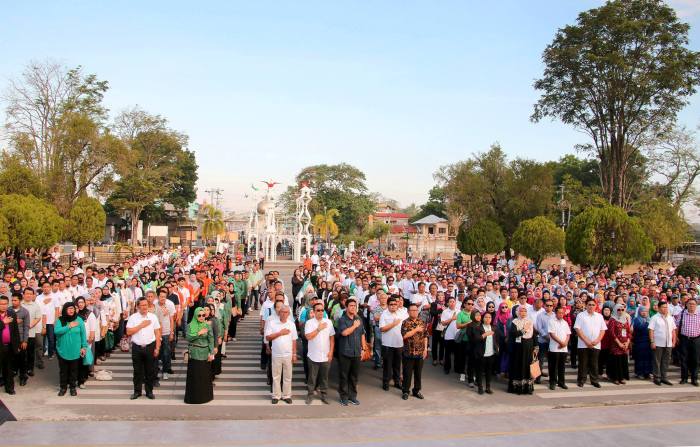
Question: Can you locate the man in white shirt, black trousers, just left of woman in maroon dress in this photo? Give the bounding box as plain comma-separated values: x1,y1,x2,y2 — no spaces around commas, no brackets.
574,298,608,388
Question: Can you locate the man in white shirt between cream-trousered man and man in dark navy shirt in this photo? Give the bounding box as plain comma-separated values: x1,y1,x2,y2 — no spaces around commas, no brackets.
304,302,335,405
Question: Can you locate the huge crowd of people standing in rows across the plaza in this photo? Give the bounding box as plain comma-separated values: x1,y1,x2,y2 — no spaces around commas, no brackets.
0,250,700,406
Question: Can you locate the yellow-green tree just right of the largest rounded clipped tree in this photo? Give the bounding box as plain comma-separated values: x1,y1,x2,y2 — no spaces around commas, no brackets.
635,197,692,260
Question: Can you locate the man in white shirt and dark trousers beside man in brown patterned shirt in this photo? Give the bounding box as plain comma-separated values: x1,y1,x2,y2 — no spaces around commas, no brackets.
379,297,408,391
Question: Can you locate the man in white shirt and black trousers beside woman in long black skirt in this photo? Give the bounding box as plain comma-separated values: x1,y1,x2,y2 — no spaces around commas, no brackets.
126,298,161,400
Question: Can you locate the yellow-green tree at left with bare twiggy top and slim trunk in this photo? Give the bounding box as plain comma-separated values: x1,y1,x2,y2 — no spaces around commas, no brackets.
108,109,194,244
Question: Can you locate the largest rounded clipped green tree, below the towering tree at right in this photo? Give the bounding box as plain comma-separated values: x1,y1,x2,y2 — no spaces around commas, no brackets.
566,205,654,271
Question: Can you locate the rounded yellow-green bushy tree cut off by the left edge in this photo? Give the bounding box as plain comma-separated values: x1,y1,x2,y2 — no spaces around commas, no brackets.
0,194,65,251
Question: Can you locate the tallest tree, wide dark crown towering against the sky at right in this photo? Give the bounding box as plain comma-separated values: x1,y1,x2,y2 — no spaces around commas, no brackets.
532,0,700,209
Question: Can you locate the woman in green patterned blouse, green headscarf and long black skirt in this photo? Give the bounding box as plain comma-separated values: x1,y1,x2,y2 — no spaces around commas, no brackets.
185,307,214,404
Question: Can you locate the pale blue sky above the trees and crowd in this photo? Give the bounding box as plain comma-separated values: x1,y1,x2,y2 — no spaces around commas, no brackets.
0,0,700,211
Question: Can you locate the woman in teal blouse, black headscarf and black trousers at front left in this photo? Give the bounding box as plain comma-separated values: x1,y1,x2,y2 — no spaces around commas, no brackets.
54,301,87,396
